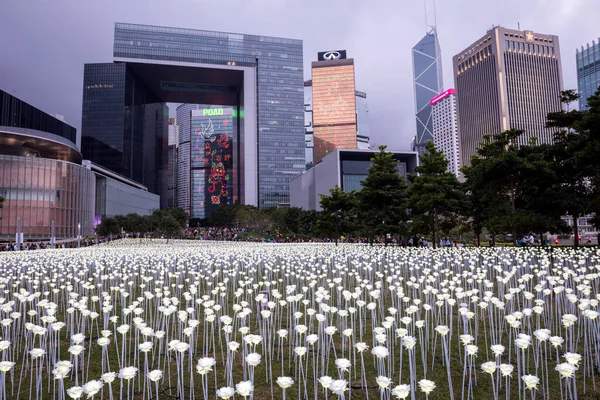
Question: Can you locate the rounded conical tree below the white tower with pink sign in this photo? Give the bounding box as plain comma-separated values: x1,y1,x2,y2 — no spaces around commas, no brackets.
408,142,467,247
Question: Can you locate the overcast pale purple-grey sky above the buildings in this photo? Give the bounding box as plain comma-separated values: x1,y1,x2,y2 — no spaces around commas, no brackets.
0,0,600,150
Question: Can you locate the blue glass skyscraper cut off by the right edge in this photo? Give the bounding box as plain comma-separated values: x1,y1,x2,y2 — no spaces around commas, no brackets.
576,39,600,110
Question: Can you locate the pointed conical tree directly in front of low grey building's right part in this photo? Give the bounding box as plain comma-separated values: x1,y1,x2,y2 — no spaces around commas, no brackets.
357,146,408,244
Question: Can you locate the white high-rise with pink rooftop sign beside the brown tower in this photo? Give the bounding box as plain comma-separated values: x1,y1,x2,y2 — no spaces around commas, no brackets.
429,89,461,178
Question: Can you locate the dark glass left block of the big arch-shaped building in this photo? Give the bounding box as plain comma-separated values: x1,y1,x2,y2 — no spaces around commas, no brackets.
81,63,169,201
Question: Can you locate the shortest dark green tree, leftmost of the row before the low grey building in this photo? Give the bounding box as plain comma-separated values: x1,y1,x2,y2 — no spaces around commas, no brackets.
317,185,356,245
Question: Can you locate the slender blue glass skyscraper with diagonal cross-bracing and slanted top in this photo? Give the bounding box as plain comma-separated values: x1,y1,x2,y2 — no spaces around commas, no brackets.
412,28,443,154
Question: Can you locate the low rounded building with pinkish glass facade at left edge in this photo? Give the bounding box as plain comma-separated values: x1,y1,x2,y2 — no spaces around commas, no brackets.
0,92,95,241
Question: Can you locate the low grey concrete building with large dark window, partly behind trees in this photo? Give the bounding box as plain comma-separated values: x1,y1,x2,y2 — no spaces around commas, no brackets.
290,149,418,211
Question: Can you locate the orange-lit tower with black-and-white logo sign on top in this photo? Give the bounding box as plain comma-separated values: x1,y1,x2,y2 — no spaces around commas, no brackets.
312,50,356,164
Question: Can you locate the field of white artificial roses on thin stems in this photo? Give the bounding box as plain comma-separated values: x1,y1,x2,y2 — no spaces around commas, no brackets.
0,240,600,400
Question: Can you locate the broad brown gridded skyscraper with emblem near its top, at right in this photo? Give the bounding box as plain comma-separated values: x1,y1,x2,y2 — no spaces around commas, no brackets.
453,27,563,165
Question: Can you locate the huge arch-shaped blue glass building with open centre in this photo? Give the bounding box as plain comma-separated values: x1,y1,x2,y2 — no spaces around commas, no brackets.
82,23,305,212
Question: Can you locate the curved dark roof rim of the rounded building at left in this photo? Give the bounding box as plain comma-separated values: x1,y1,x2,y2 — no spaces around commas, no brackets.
0,126,82,164
